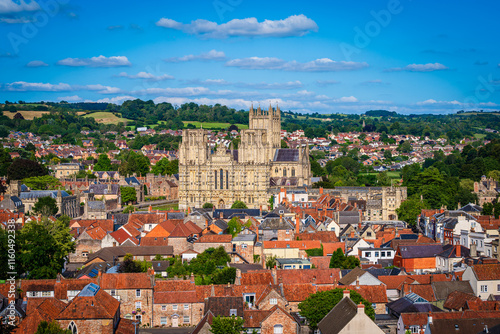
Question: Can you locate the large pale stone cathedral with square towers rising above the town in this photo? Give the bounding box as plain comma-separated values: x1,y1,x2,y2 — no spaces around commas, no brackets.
179,106,311,209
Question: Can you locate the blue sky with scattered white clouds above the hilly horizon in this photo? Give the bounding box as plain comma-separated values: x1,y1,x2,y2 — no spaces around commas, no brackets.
0,0,500,113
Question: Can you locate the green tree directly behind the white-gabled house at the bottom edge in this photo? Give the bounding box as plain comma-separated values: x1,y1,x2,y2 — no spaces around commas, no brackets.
299,288,375,329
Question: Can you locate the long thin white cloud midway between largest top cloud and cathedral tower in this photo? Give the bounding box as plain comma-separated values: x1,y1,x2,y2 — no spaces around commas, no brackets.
226,57,368,72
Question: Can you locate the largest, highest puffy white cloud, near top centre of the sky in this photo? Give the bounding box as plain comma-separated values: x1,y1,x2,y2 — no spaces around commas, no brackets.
156,14,318,38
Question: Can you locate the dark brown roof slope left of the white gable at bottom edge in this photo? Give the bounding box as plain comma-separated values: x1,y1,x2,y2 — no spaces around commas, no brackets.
318,297,358,334
